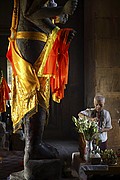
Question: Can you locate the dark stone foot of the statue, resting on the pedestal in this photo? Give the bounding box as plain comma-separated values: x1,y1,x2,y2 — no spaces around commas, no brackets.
30,142,59,160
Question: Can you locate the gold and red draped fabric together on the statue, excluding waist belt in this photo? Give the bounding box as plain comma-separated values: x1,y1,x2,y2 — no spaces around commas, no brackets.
6,27,70,132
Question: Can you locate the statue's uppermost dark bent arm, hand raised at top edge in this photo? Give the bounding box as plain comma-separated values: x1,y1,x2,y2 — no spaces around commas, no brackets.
21,0,78,27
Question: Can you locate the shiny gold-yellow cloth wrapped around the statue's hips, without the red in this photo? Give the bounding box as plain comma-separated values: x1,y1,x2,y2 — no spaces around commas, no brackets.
7,27,59,132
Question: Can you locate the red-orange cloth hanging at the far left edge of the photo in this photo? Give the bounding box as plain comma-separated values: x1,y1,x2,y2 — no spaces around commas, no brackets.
0,77,10,113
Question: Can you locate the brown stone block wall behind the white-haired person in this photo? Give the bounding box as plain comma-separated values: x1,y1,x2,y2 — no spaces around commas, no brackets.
84,0,120,149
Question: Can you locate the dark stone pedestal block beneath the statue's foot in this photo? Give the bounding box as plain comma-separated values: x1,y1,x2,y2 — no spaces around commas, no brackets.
10,159,61,180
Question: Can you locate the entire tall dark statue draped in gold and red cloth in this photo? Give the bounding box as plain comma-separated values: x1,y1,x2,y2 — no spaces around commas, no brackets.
6,0,78,179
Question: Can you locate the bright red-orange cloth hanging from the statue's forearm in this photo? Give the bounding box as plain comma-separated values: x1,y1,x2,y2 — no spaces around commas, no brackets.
43,28,71,100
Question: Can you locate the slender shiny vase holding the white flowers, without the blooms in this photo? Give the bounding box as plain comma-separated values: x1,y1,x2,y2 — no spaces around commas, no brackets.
85,140,93,163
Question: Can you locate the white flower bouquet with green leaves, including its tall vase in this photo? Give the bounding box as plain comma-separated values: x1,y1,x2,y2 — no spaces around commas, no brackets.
72,116,98,162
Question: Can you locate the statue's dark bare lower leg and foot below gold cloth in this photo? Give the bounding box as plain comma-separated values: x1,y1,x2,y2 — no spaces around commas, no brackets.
24,106,59,163
